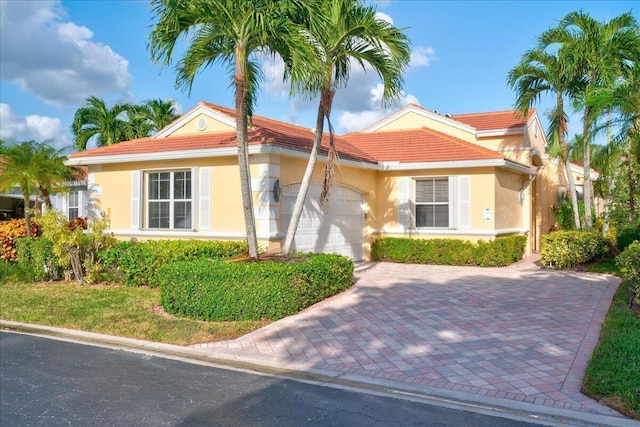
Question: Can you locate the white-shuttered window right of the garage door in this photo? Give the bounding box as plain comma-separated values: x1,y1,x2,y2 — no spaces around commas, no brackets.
415,177,450,228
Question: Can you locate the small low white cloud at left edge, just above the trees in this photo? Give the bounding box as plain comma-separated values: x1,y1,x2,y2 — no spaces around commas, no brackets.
0,104,72,149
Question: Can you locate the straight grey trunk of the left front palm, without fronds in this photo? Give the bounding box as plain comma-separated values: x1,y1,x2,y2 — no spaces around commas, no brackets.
235,45,258,259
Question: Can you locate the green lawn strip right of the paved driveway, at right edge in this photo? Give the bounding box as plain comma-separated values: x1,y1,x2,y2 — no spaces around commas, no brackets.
583,263,640,419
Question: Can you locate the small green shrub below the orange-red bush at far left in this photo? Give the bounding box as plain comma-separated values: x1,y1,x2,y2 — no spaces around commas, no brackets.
16,237,59,281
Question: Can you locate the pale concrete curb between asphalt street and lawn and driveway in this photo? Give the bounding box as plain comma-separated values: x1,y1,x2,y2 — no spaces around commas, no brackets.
0,320,639,427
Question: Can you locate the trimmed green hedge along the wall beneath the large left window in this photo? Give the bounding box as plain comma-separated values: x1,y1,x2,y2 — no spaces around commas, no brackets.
98,239,247,287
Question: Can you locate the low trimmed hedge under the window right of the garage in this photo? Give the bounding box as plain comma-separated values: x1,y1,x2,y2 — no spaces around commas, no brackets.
371,236,527,267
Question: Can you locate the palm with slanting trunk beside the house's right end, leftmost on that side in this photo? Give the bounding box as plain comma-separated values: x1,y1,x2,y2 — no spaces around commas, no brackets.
507,46,580,230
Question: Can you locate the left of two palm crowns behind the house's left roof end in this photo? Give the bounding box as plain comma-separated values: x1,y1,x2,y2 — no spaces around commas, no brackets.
71,96,131,151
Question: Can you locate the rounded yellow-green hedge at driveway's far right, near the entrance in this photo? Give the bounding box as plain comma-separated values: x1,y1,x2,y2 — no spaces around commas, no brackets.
540,230,607,268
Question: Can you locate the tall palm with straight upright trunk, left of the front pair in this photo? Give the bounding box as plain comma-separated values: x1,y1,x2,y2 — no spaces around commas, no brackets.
149,0,313,258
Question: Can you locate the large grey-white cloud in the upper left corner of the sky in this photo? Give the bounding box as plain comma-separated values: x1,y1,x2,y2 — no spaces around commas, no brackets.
0,0,131,106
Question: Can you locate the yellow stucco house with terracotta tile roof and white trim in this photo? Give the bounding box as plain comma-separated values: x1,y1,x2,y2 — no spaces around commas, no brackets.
67,102,576,260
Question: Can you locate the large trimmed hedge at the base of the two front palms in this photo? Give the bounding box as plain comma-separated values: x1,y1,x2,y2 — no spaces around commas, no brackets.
158,254,353,321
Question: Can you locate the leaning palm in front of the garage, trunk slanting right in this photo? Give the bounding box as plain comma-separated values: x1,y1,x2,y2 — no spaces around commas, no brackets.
282,0,411,256
